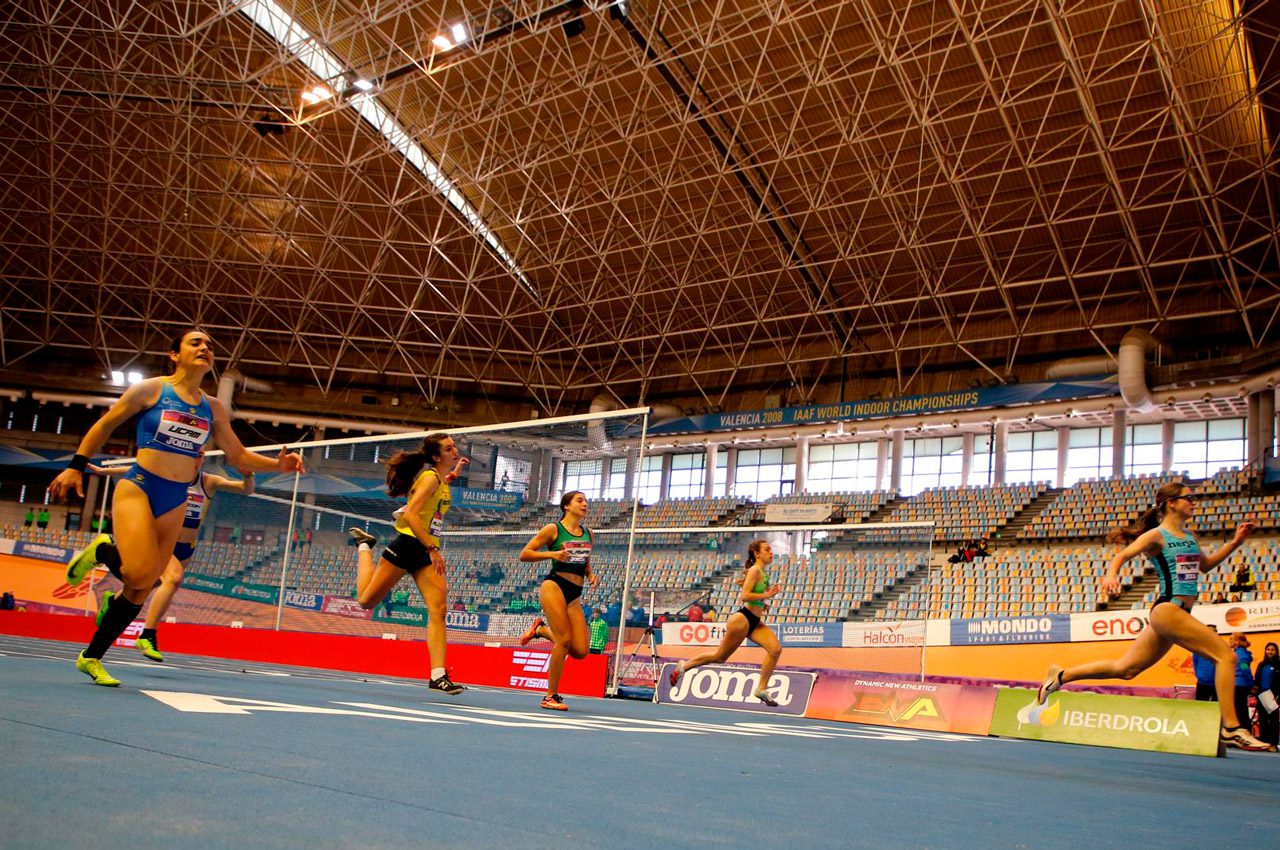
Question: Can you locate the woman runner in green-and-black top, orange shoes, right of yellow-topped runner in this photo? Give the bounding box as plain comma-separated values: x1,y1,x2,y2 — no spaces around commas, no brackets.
520,490,600,712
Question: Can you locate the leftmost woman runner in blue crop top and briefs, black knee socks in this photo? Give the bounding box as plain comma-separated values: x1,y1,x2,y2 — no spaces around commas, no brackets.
49,330,305,687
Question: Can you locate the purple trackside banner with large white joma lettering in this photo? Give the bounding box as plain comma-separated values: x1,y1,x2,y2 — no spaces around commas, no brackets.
658,663,817,717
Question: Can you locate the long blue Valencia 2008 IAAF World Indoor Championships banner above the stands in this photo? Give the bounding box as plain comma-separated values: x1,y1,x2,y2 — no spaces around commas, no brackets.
649,380,1120,434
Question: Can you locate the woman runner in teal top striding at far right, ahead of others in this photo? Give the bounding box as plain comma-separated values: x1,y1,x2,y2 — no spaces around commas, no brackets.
1036,481,1276,751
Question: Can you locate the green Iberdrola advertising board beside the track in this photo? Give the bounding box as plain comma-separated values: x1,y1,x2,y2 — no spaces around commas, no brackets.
991,687,1221,757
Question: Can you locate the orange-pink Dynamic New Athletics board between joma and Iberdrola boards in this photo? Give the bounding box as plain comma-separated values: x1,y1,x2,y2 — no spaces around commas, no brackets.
803,671,996,735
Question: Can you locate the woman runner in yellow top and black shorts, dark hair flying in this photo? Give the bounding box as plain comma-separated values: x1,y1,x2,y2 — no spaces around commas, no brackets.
348,434,468,695
